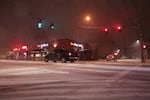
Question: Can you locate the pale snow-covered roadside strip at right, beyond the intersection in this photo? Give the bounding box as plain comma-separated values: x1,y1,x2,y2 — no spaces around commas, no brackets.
93,59,150,67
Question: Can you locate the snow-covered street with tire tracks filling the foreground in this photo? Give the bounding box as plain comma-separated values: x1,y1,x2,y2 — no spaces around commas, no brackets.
0,63,150,100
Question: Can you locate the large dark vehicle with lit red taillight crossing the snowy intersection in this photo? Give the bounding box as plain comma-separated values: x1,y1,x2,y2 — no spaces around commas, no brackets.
44,49,78,63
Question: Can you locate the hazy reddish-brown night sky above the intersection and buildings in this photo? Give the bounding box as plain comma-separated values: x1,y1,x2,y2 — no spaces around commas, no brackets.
0,0,150,54
